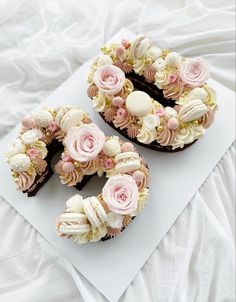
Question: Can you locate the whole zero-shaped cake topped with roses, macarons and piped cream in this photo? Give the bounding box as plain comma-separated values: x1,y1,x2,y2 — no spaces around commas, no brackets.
88,35,217,152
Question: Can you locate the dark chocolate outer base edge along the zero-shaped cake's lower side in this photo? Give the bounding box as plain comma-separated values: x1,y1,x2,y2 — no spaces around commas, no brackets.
99,112,197,153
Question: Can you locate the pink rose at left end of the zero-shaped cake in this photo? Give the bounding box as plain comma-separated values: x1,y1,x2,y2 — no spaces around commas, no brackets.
93,65,125,95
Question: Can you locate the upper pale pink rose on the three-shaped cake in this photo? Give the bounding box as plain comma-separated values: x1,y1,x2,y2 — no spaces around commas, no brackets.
65,123,105,162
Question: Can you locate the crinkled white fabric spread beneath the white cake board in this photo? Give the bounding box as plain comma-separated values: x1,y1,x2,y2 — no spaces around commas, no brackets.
0,0,235,302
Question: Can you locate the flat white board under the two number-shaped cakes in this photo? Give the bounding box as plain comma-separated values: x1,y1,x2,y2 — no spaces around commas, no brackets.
0,30,235,302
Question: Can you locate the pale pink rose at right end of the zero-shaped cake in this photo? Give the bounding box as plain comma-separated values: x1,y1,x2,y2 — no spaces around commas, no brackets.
180,58,209,87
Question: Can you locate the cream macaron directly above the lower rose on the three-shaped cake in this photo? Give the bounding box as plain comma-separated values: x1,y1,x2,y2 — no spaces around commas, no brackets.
115,152,141,174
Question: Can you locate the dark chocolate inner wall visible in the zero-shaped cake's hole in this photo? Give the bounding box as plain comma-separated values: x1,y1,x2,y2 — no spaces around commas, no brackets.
126,71,175,107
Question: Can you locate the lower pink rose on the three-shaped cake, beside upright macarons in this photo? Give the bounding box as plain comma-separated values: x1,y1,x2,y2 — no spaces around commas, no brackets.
102,174,139,215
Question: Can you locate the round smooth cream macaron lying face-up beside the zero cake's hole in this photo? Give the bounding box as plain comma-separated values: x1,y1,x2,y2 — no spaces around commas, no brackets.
126,91,152,116
